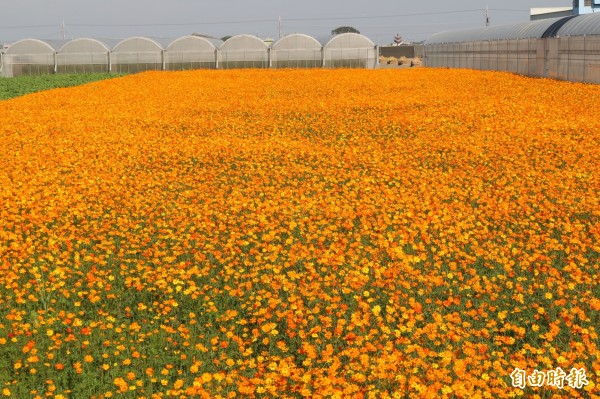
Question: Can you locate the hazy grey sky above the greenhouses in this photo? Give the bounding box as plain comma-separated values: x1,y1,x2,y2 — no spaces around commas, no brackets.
0,0,571,44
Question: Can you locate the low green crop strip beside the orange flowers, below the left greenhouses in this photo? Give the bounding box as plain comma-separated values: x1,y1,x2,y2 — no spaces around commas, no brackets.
0,73,122,100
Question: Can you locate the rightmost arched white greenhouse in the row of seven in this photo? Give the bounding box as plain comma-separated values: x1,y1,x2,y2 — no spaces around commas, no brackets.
321,33,377,68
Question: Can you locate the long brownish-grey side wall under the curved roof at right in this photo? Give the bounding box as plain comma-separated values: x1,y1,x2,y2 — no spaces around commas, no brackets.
424,36,600,83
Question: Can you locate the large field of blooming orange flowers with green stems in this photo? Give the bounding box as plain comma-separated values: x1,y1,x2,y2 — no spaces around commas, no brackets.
0,68,600,399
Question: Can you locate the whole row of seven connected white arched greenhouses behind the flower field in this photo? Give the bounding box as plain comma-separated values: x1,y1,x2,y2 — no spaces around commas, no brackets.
0,33,377,77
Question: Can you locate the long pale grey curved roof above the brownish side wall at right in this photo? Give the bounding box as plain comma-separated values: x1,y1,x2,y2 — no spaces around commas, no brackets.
425,18,562,44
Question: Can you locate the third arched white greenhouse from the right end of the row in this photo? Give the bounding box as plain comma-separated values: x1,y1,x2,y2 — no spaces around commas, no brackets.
219,35,269,69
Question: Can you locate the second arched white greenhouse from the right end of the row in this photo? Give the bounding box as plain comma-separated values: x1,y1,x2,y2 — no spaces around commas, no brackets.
271,33,323,68
